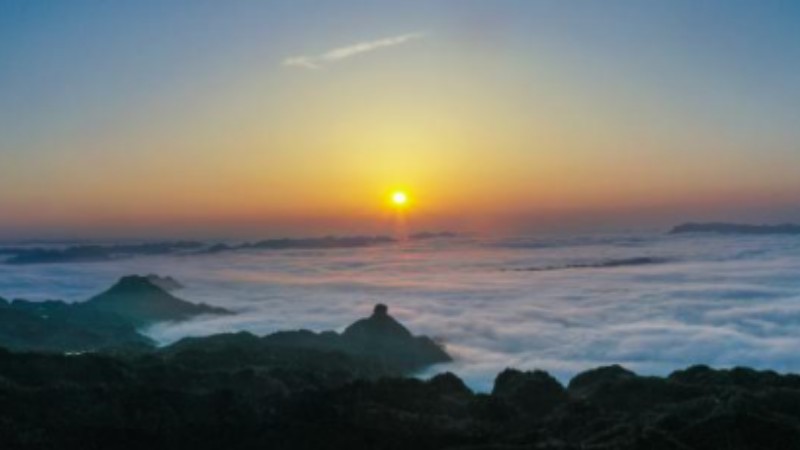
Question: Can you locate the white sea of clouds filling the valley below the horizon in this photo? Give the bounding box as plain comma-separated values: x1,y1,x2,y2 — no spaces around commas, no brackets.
0,234,800,390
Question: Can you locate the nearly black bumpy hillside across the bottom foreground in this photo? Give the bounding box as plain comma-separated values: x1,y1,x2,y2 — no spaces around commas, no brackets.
0,348,800,450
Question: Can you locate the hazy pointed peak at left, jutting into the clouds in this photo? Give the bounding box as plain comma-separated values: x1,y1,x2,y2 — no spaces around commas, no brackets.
85,275,232,326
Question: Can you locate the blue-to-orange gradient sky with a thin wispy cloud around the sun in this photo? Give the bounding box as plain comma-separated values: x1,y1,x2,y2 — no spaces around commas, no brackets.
0,0,800,239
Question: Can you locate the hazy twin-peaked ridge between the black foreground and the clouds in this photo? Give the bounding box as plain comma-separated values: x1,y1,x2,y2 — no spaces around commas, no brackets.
0,275,451,366
